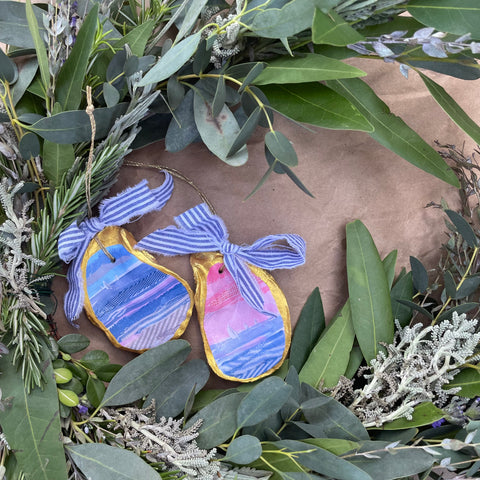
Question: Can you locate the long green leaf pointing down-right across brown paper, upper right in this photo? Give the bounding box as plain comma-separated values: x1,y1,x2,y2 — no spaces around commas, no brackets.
327,78,460,188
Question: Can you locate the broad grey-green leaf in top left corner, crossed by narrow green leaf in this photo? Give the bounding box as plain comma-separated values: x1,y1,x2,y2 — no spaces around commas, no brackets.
0,0,46,48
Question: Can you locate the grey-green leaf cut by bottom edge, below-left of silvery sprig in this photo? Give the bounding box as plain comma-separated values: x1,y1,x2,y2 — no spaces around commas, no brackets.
67,443,162,480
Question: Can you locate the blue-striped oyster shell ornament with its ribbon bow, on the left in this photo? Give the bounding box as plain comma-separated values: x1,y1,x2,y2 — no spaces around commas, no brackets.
58,173,193,352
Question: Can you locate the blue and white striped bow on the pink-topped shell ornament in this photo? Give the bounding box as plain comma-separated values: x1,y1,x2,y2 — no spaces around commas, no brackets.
135,203,305,311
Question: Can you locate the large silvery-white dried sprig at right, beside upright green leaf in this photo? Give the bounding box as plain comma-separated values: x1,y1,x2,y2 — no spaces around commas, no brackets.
337,312,480,427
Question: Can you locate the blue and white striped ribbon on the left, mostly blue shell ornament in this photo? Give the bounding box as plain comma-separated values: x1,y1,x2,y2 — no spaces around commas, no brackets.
58,172,173,322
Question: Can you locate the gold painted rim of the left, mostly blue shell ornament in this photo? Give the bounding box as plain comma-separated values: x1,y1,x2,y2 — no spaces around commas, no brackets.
80,226,194,353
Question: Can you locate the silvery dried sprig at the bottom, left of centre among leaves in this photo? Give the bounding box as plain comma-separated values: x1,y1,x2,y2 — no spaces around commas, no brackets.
99,403,220,480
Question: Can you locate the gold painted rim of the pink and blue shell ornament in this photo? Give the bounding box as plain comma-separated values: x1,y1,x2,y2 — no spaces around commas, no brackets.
190,252,292,383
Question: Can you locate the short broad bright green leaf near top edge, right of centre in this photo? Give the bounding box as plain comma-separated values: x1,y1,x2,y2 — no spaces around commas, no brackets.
312,8,364,47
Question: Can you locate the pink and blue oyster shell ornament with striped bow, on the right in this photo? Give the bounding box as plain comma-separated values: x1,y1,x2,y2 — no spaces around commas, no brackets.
135,203,305,382
